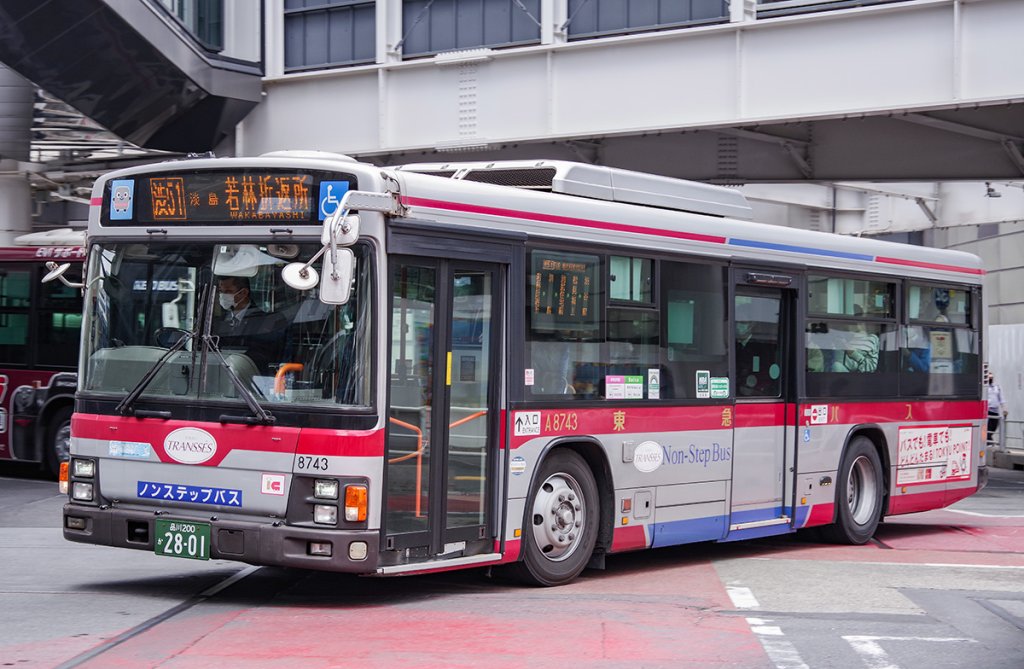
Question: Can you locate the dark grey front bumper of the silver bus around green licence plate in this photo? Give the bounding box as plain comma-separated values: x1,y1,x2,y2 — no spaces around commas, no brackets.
63,503,380,574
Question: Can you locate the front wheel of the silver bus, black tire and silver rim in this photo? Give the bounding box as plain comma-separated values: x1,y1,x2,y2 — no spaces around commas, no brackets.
513,449,601,586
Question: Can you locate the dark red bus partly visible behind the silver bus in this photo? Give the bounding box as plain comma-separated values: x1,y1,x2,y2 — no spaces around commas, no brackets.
0,234,85,474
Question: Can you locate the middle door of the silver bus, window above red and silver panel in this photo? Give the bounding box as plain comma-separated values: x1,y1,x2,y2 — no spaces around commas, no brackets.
729,278,797,539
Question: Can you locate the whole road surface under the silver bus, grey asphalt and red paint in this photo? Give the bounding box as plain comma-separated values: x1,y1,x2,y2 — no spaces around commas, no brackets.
0,469,1024,669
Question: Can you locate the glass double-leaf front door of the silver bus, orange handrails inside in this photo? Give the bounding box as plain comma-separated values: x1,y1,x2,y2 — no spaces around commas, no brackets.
381,257,504,568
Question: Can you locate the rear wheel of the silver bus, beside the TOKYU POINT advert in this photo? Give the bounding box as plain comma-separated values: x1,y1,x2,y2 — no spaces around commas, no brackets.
821,436,885,545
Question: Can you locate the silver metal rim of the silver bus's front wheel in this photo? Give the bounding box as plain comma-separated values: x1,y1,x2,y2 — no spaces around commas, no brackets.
532,473,587,562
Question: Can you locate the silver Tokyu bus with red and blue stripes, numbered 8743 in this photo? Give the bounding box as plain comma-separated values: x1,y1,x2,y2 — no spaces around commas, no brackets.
63,152,986,585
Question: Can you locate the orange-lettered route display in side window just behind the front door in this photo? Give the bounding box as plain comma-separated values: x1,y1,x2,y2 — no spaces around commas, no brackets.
530,252,600,332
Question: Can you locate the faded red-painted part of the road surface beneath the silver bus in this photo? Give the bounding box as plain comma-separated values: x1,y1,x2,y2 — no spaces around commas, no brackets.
16,499,1007,669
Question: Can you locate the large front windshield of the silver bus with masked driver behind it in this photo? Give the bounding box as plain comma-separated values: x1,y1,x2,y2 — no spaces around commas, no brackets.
80,242,372,407
